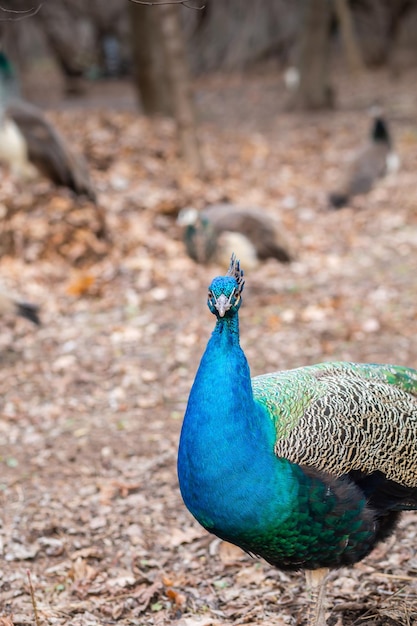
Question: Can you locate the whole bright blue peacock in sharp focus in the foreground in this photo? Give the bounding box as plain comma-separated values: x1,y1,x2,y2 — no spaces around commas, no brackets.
178,256,417,626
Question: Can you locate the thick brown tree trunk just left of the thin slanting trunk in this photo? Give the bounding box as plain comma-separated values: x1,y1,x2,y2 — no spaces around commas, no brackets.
128,2,173,116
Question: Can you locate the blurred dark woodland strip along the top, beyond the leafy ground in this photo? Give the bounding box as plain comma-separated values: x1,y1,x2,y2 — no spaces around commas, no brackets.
1,0,417,107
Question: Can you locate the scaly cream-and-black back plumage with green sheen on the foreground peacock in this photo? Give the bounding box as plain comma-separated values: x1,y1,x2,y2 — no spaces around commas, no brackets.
252,363,417,487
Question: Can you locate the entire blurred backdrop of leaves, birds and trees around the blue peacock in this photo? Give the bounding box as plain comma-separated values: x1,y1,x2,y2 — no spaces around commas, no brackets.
0,0,417,626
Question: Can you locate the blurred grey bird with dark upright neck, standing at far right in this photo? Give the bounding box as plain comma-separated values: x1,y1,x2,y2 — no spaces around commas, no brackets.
329,108,399,209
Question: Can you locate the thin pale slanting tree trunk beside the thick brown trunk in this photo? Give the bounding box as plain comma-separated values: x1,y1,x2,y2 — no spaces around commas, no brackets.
157,4,202,174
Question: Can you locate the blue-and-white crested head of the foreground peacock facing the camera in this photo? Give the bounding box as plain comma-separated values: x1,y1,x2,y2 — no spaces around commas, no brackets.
207,254,245,318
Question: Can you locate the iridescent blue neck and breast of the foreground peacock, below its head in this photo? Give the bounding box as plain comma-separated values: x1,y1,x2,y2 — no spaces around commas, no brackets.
178,314,294,539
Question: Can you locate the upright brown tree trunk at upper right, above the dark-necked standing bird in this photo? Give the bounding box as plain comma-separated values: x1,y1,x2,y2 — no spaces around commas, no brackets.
294,0,333,110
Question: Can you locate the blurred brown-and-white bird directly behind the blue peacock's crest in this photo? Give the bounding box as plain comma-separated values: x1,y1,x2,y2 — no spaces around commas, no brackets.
178,203,291,268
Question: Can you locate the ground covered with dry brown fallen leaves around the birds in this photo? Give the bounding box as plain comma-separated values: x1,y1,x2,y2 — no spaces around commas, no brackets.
0,66,417,626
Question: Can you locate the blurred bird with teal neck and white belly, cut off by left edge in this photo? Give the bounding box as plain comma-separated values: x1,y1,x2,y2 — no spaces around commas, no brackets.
0,51,96,202
